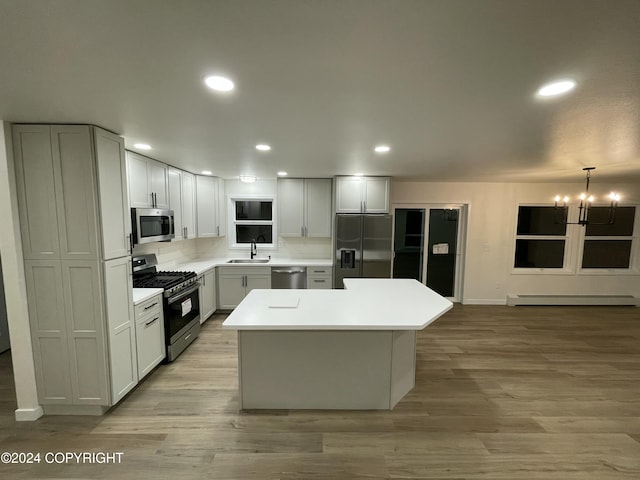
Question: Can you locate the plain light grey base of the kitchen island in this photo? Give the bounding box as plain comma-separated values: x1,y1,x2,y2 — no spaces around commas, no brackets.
238,330,416,410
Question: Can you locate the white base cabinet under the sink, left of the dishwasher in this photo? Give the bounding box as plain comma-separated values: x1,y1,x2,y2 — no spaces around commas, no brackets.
218,267,271,310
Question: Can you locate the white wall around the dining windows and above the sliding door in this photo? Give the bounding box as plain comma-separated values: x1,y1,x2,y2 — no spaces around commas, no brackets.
391,177,640,304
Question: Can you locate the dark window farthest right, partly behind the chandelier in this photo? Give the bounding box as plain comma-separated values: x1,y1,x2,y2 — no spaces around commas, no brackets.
581,207,636,269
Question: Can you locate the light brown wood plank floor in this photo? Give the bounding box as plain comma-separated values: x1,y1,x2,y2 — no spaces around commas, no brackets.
0,306,640,480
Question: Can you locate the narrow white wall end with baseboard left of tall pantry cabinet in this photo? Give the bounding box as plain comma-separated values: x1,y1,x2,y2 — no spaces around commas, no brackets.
0,122,42,420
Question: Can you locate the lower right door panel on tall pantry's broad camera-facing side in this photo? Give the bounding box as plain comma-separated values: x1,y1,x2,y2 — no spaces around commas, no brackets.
62,257,109,405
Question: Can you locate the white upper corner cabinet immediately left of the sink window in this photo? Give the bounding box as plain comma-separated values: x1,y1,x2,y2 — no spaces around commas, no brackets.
195,175,226,238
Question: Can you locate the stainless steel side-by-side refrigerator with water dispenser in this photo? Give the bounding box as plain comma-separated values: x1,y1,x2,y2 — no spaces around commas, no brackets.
333,214,392,288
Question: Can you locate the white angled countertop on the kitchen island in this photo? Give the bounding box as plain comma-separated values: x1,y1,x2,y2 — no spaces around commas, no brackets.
222,278,453,330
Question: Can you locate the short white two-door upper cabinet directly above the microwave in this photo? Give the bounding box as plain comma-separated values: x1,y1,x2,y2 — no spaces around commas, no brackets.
127,151,169,208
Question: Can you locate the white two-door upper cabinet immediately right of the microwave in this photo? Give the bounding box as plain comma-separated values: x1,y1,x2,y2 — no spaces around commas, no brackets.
169,167,196,240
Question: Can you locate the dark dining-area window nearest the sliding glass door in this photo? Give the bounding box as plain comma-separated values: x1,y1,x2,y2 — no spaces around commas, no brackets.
514,206,567,269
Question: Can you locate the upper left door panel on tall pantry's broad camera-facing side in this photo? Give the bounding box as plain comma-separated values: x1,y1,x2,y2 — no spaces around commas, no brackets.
13,125,60,260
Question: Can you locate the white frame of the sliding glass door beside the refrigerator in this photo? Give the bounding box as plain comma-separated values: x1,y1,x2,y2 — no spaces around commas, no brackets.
391,203,469,303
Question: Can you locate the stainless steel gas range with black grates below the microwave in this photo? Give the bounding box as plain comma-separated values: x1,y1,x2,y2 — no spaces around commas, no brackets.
132,254,200,362
